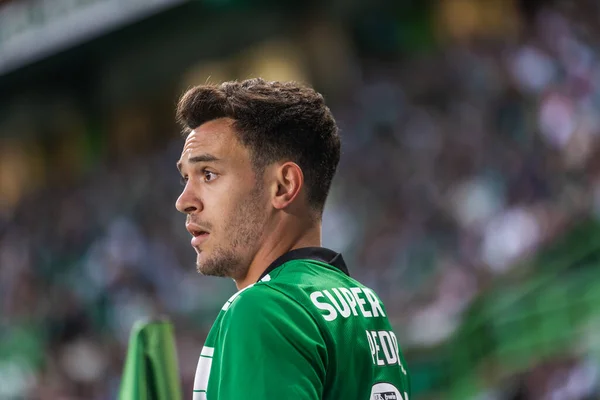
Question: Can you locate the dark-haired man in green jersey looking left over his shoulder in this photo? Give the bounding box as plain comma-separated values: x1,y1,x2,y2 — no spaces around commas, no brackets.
172,79,410,400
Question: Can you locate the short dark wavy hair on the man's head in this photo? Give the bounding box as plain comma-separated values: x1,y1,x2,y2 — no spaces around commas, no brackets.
177,78,340,213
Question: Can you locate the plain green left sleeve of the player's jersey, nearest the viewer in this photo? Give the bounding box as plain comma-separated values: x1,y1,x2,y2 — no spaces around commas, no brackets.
211,285,327,400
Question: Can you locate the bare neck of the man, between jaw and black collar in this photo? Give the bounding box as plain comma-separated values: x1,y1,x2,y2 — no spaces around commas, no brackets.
235,220,321,290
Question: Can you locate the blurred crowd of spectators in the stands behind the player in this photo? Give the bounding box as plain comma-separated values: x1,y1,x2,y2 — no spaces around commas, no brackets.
0,2,600,399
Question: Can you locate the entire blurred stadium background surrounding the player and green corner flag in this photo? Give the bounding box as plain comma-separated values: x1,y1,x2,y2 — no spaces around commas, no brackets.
0,0,600,400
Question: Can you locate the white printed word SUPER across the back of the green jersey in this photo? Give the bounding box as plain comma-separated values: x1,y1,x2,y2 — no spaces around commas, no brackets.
310,287,385,321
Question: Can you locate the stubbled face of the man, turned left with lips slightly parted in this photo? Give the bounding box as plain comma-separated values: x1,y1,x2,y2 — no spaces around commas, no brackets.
176,118,269,279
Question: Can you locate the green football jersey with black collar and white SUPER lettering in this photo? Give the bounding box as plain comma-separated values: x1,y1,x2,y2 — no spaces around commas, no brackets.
193,247,410,400
